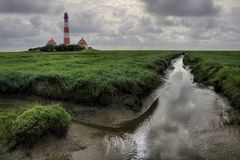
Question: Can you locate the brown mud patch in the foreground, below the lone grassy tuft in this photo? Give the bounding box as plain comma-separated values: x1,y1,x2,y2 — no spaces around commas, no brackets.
6,123,96,160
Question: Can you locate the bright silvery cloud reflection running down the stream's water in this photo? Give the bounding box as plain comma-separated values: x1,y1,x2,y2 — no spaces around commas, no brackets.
133,58,201,160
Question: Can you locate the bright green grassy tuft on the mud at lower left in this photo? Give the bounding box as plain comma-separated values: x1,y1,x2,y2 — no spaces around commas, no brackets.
0,104,71,159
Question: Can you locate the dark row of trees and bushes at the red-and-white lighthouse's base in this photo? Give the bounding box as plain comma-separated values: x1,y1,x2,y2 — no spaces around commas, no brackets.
28,44,86,52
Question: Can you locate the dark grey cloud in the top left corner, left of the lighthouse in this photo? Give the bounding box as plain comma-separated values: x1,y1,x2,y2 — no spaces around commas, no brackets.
0,0,64,14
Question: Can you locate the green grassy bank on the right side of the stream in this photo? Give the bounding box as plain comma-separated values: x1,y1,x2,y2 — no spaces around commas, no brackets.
184,51,240,125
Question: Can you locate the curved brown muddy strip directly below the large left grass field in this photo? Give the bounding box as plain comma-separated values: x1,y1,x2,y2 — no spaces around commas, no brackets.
0,87,161,129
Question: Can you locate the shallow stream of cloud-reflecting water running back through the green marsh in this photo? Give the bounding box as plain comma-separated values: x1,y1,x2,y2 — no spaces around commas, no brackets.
94,57,240,160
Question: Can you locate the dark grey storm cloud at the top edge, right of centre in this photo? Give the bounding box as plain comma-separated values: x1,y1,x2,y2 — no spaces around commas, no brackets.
143,0,220,17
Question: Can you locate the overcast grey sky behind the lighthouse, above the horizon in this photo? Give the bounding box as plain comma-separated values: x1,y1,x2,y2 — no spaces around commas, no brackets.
0,0,240,51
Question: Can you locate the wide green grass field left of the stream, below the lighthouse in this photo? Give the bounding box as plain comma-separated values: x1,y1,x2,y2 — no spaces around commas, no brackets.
0,51,180,109
